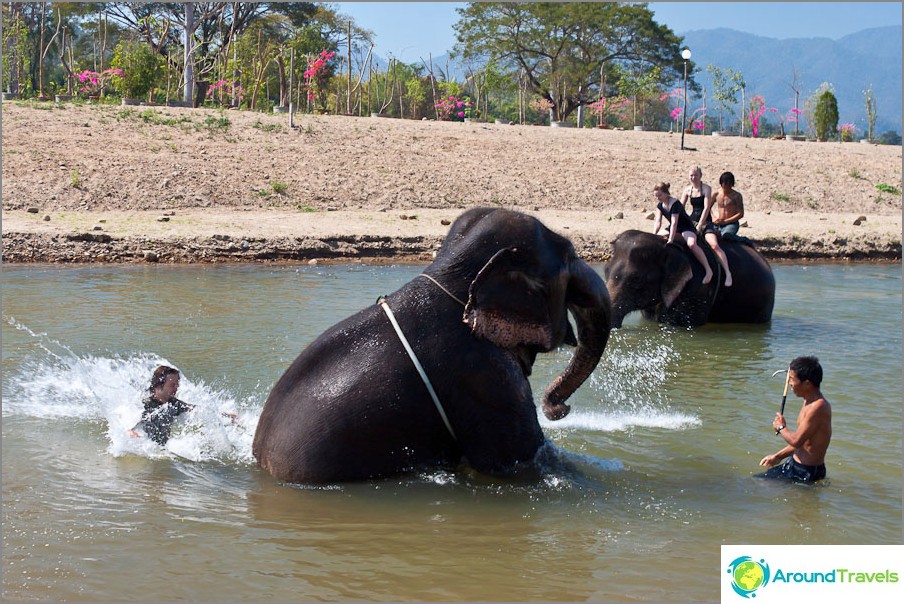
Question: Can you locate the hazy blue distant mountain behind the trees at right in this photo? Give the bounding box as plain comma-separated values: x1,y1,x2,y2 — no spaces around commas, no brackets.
684,25,902,135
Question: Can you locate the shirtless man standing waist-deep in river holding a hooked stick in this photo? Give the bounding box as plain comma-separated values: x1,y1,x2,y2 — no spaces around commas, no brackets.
757,357,832,482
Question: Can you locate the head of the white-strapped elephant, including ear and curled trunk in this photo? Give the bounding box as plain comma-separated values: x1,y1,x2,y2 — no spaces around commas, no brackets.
431,208,611,420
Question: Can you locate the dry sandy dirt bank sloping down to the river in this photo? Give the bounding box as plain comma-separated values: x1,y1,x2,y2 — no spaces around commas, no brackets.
2,101,902,262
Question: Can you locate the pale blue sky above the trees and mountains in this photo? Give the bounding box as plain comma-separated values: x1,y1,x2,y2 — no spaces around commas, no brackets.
331,2,902,63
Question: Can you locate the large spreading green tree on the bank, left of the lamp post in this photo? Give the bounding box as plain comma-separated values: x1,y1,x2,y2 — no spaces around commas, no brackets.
454,2,684,121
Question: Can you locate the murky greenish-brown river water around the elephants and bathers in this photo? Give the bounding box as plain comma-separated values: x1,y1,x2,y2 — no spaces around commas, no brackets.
2,264,902,601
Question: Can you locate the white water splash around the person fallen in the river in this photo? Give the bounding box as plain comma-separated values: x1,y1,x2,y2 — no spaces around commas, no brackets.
3,316,260,463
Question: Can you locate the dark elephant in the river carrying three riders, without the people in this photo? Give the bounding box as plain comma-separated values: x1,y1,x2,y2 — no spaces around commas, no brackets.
605,230,775,327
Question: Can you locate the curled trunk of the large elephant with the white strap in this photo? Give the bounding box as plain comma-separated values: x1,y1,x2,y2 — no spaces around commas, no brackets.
543,263,612,420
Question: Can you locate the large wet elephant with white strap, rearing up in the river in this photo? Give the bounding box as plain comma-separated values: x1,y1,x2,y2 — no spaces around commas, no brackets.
252,208,611,484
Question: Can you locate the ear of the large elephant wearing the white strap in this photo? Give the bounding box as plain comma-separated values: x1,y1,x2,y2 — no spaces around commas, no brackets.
464,248,554,350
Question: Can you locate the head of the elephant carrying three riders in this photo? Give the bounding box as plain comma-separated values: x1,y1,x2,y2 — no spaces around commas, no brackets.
605,230,708,327
